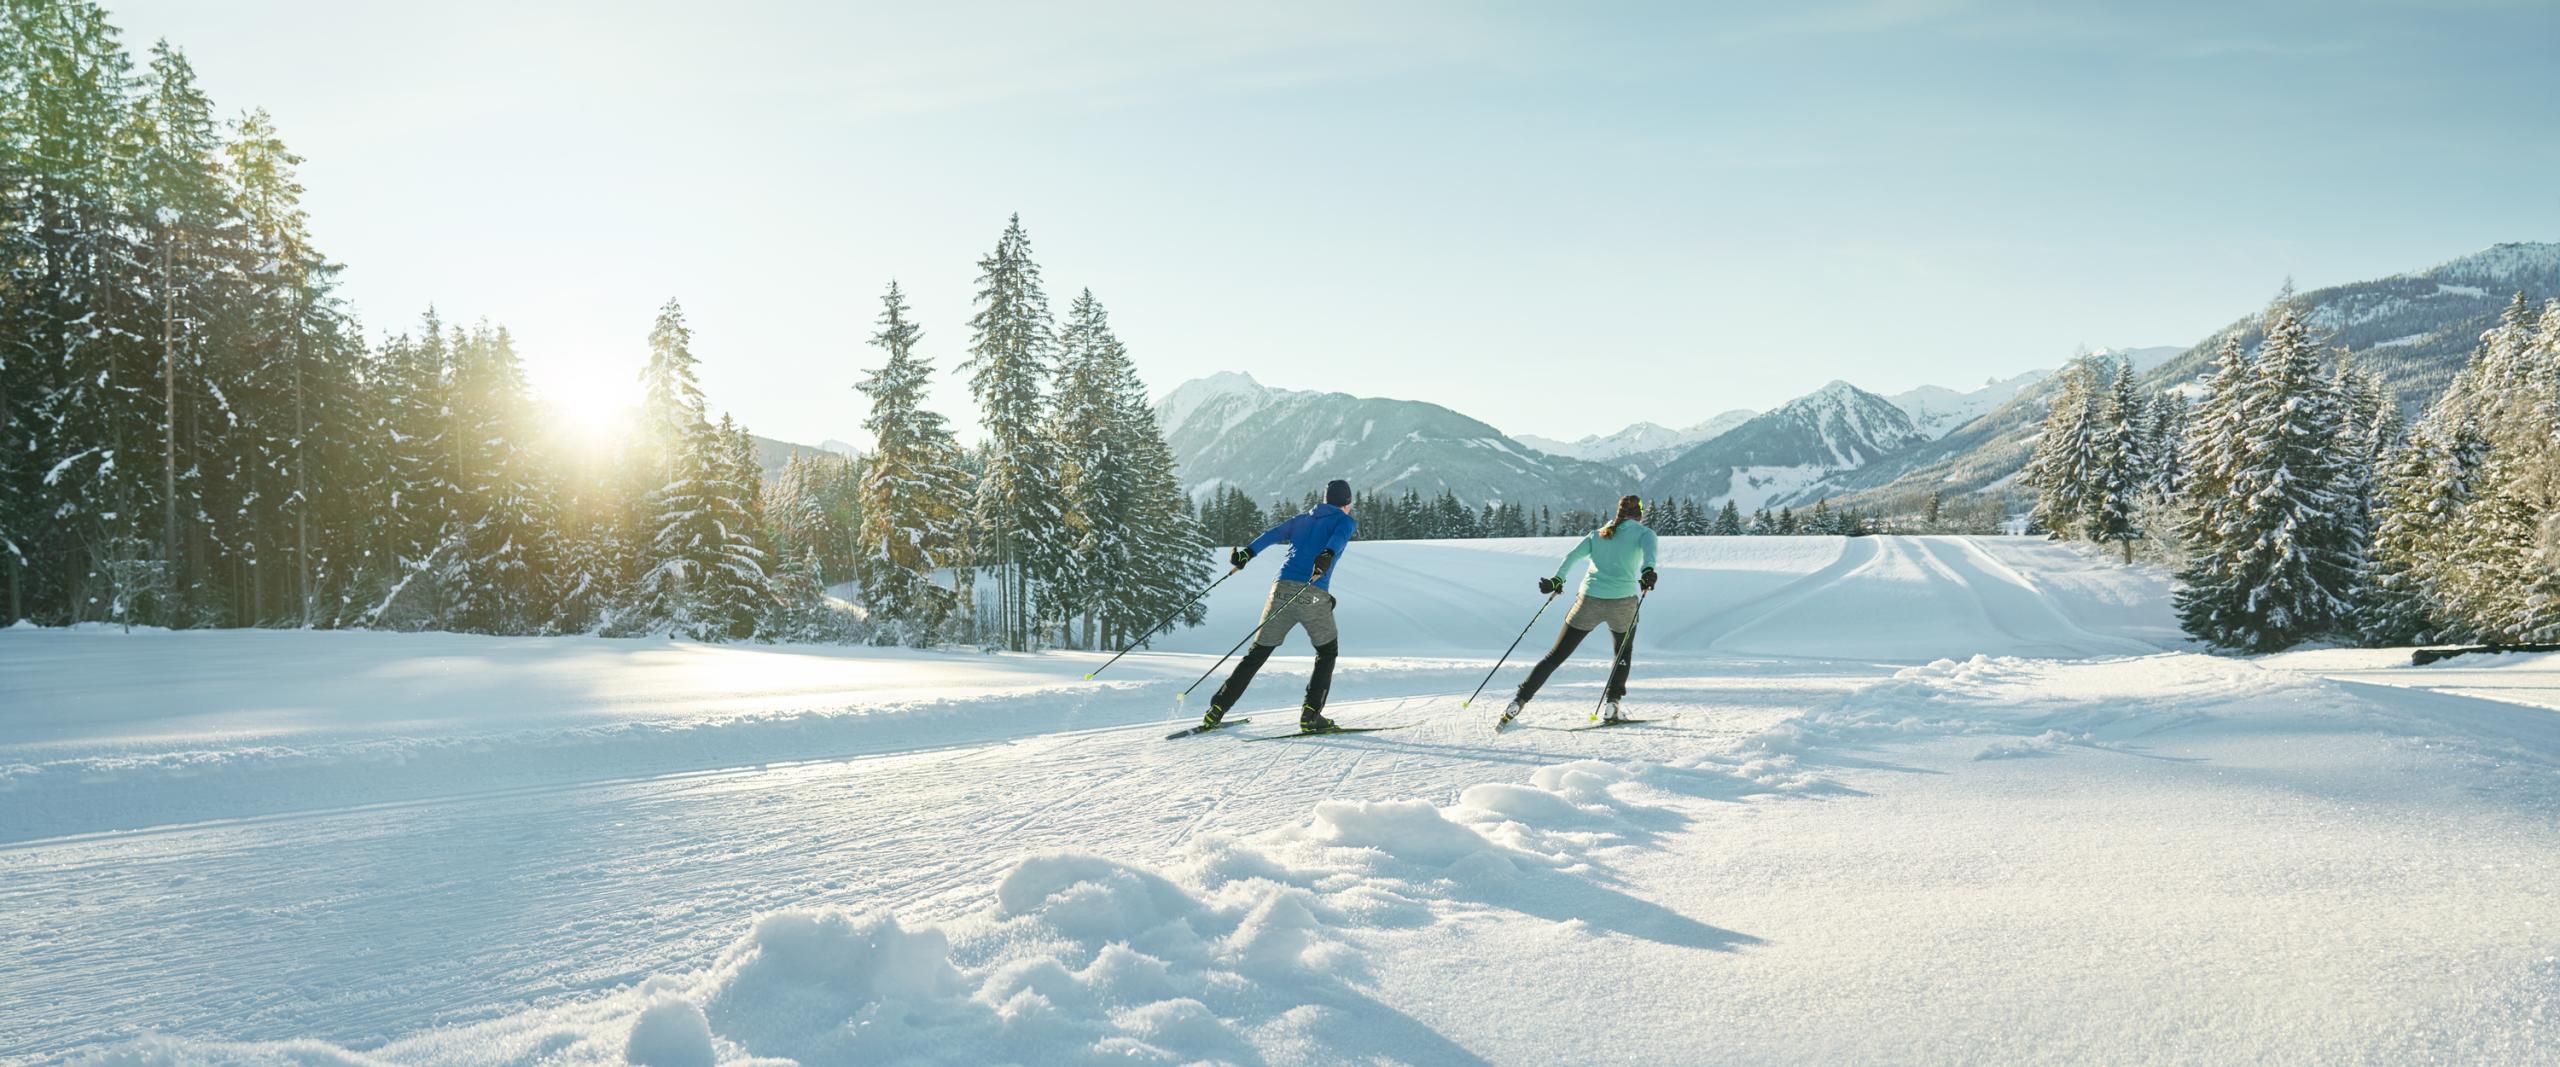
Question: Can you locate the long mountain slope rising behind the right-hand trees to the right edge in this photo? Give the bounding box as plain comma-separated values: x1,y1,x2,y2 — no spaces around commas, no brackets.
1825,243,2560,512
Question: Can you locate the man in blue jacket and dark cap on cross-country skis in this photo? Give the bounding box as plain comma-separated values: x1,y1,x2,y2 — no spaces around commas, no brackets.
1201,478,1359,734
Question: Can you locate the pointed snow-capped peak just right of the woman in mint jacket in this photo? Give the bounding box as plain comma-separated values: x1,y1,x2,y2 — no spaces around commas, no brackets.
1644,381,1928,509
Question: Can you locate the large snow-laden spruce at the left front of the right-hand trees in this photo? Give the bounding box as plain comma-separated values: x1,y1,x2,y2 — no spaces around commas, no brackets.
2179,307,2363,652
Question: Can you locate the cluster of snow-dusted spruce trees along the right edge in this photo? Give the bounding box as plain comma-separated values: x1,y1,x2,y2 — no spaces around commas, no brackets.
2028,294,2560,652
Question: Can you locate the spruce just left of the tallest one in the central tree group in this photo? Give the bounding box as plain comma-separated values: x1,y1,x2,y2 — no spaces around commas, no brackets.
855,281,970,645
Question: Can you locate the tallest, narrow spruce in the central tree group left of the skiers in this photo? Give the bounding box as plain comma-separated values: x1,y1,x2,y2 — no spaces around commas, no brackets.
963,215,1068,650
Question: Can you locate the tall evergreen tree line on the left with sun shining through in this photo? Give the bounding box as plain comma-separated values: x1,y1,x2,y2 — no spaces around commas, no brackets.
0,0,1206,647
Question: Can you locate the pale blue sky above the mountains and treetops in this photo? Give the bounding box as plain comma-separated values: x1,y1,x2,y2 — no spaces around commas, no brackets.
108,0,2560,443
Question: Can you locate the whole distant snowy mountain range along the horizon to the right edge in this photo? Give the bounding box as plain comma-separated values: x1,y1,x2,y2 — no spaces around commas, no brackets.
1157,243,2560,512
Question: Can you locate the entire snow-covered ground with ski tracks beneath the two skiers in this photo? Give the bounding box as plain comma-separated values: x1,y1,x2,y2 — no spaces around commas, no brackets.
0,537,2560,1064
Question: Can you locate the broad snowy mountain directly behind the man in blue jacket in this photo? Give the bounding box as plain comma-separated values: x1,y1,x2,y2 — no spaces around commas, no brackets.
1155,371,1626,507
